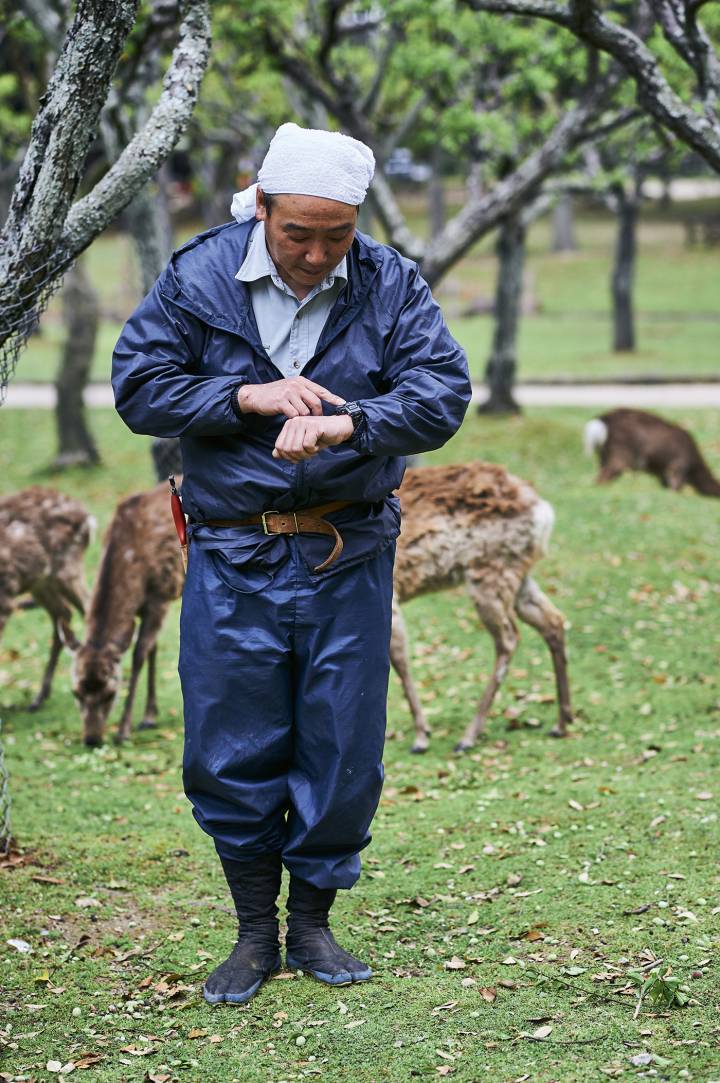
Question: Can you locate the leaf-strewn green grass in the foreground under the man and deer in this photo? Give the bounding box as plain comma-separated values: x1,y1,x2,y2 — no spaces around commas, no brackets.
0,409,720,1083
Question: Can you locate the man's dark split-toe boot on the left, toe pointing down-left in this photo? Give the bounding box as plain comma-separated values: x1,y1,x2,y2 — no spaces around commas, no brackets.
204,853,283,1004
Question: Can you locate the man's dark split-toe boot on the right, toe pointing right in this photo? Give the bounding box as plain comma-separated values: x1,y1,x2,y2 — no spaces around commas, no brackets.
286,876,372,986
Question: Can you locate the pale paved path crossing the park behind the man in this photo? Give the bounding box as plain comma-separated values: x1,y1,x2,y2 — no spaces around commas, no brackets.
4,382,720,409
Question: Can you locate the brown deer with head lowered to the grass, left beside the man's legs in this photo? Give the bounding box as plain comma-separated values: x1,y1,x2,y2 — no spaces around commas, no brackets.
73,483,183,745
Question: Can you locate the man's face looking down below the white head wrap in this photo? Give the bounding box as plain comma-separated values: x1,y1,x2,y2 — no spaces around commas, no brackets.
257,191,357,293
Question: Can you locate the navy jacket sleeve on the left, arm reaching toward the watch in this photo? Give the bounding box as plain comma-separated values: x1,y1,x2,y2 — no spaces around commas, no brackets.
113,270,244,436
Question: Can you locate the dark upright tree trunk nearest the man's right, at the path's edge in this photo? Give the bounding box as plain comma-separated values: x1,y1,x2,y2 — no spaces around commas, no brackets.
477,211,525,414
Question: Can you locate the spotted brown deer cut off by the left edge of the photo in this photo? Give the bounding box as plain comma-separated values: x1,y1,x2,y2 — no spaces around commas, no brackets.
0,485,94,710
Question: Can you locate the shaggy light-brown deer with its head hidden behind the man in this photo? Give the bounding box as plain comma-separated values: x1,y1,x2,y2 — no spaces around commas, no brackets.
390,462,573,753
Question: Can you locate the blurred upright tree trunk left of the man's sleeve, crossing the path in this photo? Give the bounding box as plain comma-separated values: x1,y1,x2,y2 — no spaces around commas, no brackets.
53,261,100,470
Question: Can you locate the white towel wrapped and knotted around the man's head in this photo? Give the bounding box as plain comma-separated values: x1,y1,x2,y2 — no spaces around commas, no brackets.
231,123,375,222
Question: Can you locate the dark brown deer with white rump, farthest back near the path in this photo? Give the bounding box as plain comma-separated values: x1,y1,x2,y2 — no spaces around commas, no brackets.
585,409,720,496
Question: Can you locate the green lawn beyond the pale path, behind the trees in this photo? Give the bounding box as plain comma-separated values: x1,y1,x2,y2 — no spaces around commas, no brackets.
17,204,720,380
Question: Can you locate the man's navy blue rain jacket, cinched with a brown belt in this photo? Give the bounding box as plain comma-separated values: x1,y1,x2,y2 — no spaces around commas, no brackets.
113,222,471,575
